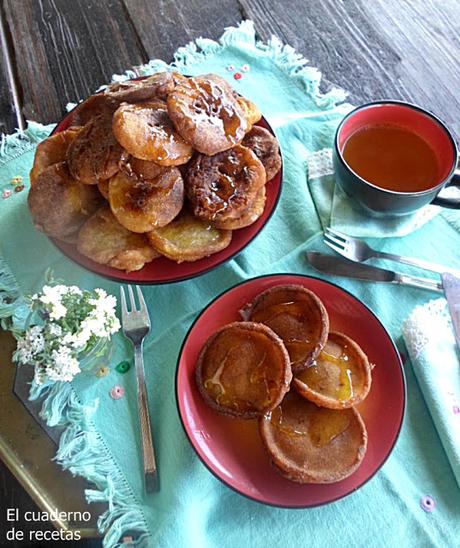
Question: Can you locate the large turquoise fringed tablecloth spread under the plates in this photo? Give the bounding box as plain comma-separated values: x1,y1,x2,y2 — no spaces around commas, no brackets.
0,22,460,548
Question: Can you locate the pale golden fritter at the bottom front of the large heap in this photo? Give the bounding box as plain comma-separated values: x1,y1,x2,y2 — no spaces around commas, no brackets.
147,210,232,263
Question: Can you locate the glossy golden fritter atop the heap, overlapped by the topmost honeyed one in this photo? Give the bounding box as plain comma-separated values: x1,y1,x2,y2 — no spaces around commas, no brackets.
113,101,193,166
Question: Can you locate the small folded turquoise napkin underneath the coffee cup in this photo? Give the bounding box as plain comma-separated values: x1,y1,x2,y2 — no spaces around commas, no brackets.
307,148,440,238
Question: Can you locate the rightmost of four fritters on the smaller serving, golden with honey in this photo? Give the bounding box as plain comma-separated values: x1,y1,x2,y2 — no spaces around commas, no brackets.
292,331,371,409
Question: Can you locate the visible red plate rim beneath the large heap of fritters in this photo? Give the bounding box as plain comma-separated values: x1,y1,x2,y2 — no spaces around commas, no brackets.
51,100,283,285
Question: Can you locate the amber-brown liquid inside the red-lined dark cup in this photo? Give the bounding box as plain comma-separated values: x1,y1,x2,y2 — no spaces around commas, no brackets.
342,124,440,192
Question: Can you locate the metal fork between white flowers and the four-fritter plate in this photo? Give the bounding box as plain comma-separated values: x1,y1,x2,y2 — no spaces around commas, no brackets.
120,285,158,493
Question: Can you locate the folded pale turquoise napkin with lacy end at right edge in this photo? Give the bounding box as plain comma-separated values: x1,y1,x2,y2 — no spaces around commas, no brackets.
403,299,460,487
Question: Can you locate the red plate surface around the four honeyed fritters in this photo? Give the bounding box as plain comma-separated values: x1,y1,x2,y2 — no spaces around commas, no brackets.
176,274,405,508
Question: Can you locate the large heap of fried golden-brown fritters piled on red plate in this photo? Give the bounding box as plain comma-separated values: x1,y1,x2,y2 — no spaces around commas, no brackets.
29,72,281,272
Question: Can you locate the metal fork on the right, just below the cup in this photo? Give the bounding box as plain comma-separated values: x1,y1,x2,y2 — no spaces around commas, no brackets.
324,228,460,276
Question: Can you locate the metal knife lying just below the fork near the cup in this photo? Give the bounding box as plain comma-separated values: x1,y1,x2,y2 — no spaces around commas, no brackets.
307,251,444,294
